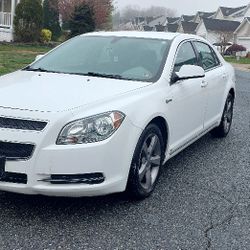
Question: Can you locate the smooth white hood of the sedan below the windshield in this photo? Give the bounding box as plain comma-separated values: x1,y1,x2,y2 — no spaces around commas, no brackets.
0,71,150,112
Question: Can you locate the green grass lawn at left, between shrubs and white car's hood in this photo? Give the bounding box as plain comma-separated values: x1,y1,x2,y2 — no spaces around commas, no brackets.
0,44,51,75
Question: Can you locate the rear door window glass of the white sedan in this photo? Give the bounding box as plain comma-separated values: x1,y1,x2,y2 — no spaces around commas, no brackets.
194,42,220,70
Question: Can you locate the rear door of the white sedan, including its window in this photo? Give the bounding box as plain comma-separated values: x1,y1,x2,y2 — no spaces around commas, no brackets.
193,41,229,129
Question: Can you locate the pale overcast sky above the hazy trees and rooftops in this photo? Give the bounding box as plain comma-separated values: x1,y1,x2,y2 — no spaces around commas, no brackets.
115,0,250,15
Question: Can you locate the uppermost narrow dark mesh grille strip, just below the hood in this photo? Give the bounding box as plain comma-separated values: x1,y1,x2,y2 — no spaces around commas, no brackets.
0,117,47,131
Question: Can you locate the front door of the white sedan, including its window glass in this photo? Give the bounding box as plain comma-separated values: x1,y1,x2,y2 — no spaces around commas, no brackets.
167,42,207,155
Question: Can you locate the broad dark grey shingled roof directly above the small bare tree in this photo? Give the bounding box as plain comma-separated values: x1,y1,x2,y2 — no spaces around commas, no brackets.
202,18,240,32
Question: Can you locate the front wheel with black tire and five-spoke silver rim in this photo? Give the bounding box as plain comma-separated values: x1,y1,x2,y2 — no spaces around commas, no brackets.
126,124,165,199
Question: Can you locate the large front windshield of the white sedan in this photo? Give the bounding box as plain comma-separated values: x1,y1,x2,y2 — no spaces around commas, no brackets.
24,36,170,81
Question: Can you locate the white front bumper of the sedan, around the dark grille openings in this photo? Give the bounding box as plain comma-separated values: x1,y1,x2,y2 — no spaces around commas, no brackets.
0,107,142,197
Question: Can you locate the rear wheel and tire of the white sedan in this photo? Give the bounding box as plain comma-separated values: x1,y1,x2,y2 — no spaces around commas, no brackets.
211,93,234,138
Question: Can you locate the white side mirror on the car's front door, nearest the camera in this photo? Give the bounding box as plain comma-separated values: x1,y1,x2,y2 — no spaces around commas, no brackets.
172,65,205,83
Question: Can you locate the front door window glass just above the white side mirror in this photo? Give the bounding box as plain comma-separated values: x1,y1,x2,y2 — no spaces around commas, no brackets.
174,42,198,72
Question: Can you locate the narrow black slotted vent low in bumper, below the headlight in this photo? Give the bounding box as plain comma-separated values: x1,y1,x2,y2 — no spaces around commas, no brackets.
41,173,105,185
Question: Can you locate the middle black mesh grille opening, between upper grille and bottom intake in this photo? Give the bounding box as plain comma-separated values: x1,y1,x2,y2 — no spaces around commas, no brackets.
0,141,35,160
